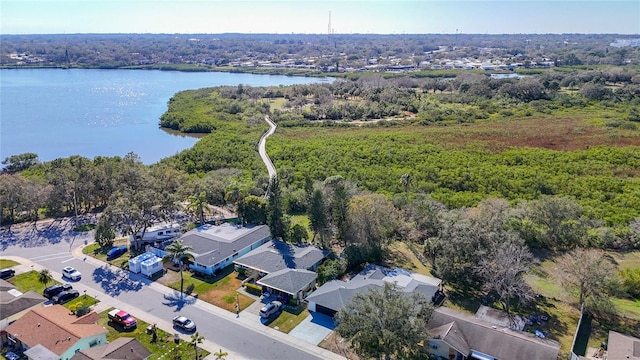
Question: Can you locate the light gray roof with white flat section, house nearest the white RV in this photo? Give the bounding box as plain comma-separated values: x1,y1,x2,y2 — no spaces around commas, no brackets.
180,223,271,266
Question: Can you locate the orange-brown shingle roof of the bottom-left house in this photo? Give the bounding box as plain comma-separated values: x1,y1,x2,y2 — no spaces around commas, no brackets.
6,305,107,355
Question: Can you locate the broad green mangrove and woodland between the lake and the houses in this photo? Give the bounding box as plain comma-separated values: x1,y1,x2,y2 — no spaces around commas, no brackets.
0,58,640,354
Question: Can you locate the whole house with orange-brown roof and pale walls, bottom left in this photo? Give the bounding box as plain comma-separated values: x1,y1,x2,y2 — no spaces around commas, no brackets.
6,305,107,360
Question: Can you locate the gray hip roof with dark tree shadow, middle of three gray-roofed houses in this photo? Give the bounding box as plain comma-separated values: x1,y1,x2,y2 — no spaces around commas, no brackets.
234,240,328,274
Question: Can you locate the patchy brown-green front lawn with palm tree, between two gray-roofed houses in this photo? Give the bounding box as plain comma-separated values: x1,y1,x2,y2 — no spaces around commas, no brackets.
167,265,254,313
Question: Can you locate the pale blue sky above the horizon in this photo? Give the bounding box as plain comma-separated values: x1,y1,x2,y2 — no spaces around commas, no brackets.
0,0,640,34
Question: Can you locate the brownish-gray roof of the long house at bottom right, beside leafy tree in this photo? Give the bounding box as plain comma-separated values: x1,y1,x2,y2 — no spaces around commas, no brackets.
429,307,560,360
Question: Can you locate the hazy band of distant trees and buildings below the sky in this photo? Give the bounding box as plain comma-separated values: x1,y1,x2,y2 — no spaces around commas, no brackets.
0,34,640,71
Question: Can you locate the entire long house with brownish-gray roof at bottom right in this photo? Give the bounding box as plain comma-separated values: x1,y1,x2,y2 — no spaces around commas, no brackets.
426,307,560,360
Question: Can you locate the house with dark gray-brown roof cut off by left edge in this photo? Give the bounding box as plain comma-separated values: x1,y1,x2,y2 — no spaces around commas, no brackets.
0,279,47,330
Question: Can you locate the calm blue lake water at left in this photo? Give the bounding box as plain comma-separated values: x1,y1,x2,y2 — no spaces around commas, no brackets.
0,69,323,164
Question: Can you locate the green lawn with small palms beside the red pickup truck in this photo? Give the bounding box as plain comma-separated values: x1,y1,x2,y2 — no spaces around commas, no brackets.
98,308,209,359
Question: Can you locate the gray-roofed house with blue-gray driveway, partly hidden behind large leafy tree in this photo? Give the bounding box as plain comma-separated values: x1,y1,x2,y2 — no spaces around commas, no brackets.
307,265,442,316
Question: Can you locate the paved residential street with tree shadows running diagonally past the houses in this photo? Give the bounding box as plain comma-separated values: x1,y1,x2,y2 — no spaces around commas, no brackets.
0,219,344,359
